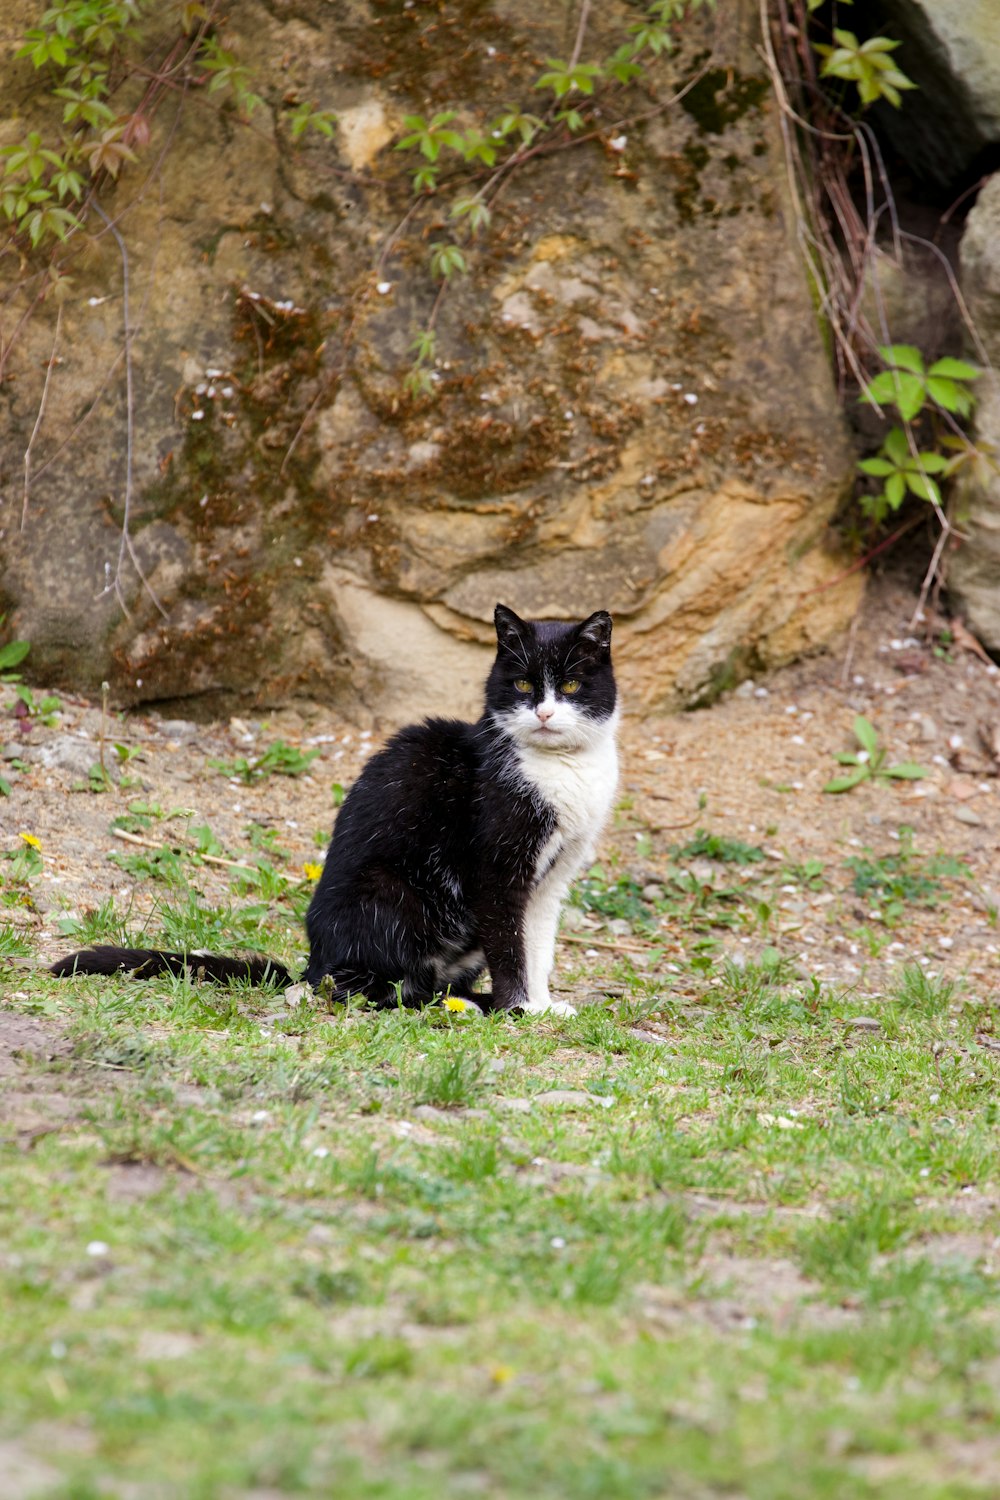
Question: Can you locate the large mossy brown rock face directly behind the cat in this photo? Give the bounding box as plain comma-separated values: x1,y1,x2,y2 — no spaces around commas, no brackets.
0,0,859,720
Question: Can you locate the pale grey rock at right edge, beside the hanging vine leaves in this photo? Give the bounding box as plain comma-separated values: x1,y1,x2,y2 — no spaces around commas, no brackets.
948,177,1000,651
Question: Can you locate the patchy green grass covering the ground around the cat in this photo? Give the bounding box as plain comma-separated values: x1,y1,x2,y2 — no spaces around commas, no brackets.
0,834,1000,1500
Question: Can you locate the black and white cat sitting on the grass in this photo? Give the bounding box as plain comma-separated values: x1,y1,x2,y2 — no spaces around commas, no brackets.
52,605,618,1014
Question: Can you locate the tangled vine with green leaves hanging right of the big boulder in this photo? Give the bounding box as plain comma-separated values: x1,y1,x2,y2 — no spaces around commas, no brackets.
760,0,988,614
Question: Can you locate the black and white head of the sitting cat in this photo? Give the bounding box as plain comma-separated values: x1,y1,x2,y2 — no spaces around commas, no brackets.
486,605,616,750
